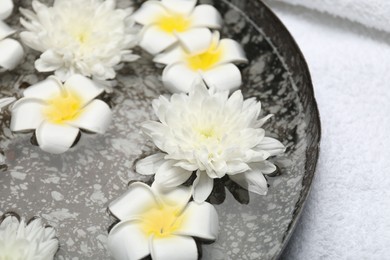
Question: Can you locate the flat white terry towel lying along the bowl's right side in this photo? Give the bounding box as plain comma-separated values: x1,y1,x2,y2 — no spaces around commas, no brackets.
266,0,390,260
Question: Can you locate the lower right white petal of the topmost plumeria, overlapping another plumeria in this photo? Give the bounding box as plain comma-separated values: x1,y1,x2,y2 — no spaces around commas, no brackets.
176,28,213,55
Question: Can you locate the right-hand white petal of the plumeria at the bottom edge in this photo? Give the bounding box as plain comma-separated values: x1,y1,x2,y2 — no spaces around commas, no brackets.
175,202,219,240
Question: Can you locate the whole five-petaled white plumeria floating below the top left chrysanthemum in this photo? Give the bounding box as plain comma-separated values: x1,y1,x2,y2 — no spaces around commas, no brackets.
11,75,112,154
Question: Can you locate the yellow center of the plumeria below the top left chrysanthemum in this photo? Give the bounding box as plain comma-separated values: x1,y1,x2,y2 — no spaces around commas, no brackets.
43,92,83,124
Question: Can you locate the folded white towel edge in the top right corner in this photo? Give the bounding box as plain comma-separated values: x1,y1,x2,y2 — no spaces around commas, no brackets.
272,0,390,32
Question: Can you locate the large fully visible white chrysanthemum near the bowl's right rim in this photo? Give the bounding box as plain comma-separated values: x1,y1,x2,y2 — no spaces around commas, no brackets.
137,84,285,202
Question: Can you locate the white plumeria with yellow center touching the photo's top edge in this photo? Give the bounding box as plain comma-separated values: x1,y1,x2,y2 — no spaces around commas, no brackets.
133,0,222,55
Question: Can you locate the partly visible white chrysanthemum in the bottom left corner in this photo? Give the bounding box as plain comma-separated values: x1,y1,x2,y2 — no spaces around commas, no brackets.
0,214,58,260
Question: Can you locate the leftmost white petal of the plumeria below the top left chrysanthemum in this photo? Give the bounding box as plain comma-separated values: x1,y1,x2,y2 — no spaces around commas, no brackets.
10,98,45,131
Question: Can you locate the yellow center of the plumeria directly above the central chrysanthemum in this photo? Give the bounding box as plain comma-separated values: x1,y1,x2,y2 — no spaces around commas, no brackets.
187,41,223,70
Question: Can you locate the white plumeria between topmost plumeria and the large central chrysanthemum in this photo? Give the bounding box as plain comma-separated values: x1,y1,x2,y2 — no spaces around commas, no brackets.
154,32,247,93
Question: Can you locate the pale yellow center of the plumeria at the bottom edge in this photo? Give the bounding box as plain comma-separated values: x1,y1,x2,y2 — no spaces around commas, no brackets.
142,205,184,237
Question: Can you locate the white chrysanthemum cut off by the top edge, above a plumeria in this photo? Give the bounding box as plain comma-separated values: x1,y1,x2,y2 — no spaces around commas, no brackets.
20,0,136,80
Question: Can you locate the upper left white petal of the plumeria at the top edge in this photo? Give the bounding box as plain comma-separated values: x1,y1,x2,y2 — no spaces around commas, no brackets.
132,1,167,25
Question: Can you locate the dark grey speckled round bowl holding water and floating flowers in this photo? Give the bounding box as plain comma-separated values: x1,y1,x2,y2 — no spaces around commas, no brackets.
0,0,320,260
